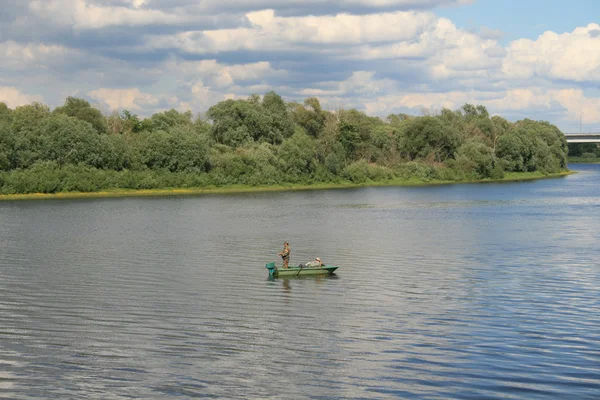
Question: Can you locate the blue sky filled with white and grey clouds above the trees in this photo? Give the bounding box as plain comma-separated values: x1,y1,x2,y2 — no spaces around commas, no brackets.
0,0,600,132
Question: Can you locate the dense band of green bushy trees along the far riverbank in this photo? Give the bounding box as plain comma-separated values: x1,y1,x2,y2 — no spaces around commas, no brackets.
0,92,567,194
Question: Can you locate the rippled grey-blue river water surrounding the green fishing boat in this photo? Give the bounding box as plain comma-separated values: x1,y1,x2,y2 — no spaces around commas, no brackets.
0,165,600,399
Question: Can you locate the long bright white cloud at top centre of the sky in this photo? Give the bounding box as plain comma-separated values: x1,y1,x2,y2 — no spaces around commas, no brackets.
149,10,436,54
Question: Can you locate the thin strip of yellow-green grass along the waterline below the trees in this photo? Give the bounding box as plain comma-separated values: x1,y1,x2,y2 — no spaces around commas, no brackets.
0,171,574,201
